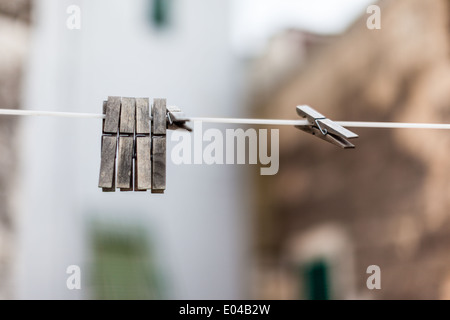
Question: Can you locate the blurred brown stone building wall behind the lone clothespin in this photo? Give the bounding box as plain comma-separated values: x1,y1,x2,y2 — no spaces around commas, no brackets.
251,0,450,299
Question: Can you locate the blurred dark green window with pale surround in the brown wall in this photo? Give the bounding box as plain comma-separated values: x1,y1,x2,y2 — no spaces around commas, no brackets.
286,224,355,300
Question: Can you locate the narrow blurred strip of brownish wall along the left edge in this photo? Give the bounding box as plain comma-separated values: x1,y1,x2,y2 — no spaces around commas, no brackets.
0,0,31,299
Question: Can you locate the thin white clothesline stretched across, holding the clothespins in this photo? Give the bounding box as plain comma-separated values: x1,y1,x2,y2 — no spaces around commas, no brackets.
0,109,450,130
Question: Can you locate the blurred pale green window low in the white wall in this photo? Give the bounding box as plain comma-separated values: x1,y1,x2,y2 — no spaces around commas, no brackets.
91,226,161,300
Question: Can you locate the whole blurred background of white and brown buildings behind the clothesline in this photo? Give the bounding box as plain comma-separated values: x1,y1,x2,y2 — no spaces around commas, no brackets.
0,0,450,299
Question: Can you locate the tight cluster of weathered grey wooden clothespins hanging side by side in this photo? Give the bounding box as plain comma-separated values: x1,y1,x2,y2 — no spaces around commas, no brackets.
98,97,190,193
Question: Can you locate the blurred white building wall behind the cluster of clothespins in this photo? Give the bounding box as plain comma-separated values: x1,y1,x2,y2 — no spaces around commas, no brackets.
17,0,247,299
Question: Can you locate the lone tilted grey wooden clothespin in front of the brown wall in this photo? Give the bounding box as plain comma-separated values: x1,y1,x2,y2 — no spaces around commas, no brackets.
295,106,358,149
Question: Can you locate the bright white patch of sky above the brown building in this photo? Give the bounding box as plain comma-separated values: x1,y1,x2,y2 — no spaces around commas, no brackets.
231,0,377,56
